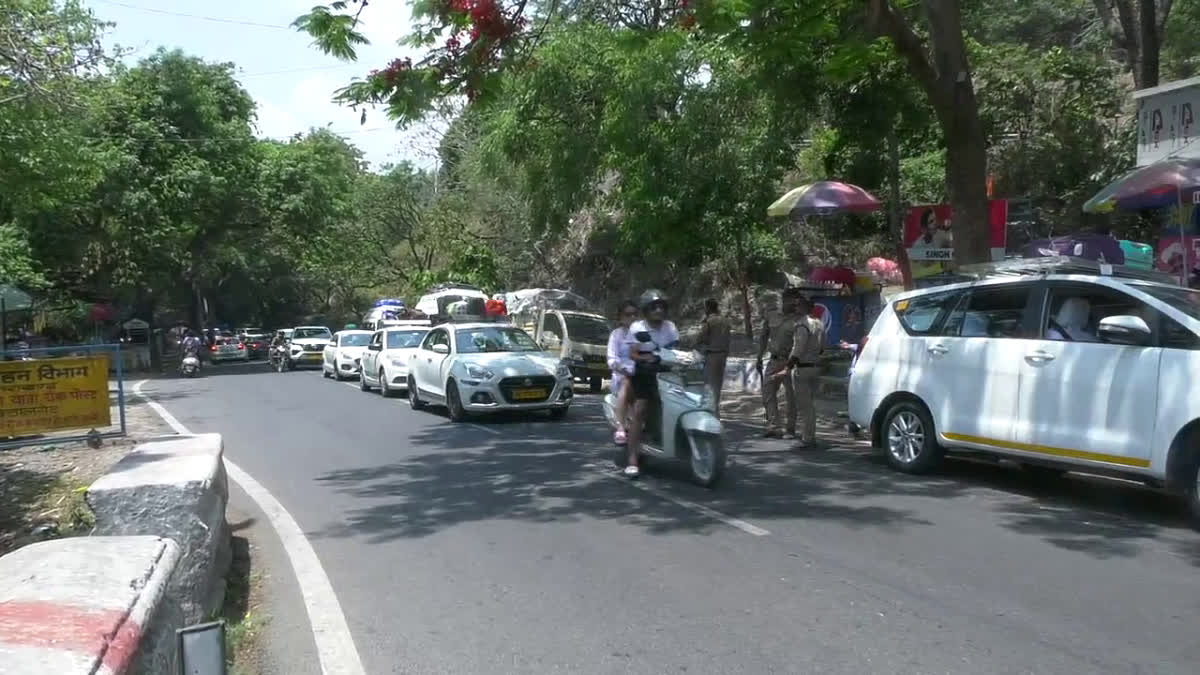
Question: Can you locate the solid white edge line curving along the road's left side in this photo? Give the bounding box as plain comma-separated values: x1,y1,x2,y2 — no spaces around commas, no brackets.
133,380,366,675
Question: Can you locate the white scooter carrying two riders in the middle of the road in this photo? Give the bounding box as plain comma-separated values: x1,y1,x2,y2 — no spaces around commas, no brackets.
604,350,727,488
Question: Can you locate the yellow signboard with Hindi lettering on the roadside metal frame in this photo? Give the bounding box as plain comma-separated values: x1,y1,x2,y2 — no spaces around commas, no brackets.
0,356,113,436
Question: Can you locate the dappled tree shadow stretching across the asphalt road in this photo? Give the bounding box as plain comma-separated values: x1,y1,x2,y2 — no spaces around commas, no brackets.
304,405,1200,566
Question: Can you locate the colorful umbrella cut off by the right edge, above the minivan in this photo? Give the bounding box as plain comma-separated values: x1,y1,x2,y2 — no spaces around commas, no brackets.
1084,157,1200,214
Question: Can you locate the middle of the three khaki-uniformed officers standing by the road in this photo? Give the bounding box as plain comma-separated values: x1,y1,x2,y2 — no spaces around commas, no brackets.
755,288,799,440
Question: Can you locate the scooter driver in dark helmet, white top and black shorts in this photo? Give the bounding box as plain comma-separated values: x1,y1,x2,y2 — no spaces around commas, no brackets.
625,288,679,478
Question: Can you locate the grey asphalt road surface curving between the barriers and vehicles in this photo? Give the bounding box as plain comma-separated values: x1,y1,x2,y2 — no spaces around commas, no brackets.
144,366,1200,675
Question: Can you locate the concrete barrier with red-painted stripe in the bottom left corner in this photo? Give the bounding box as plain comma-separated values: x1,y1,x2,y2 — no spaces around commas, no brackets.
0,537,184,675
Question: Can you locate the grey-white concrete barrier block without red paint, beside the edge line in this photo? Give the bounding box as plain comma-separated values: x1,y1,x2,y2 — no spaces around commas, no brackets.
86,434,230,623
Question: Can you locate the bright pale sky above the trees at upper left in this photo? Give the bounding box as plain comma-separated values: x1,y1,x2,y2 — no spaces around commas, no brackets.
83,0,439,169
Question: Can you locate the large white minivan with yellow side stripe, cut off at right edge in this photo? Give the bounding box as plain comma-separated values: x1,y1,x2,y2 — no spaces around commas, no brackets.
848,258,1200,520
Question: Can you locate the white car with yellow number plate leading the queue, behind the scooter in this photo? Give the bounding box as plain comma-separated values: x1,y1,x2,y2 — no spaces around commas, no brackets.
408,322,574,422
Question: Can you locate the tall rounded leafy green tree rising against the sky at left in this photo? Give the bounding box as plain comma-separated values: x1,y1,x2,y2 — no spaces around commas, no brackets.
21,50,256,336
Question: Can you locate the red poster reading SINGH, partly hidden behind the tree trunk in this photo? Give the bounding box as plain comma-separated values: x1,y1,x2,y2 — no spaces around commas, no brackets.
904,199,1008,280
